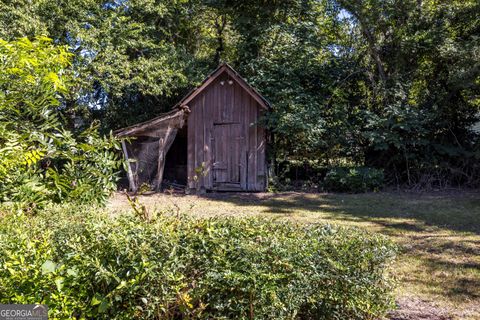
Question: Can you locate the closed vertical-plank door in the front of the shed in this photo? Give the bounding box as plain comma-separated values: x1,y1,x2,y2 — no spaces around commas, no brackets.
212,123,244,190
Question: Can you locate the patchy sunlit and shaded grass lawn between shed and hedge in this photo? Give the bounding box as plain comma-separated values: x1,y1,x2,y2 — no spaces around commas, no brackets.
109,192,480,319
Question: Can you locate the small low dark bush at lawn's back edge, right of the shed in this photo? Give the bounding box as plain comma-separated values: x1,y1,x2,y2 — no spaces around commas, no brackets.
324,167,384,192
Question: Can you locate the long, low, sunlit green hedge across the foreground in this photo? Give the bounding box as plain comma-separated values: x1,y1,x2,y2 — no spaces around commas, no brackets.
0,207,395,319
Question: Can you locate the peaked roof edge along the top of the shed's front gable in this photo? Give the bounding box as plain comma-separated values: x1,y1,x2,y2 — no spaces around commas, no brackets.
174,63,270,110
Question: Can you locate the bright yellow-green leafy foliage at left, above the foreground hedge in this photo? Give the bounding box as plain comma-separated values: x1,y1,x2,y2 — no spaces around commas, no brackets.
0,37,120,209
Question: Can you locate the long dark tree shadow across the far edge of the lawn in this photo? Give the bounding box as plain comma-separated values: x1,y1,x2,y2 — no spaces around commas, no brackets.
198,193,480,234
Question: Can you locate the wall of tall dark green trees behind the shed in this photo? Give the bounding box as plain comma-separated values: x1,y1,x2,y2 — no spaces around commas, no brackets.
0,0,480,187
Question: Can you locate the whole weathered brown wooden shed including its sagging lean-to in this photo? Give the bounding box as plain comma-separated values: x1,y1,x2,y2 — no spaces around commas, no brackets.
116,64,269,191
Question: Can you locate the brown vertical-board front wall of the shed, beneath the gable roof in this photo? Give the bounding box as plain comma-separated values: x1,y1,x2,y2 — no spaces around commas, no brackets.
187,72,267,191
